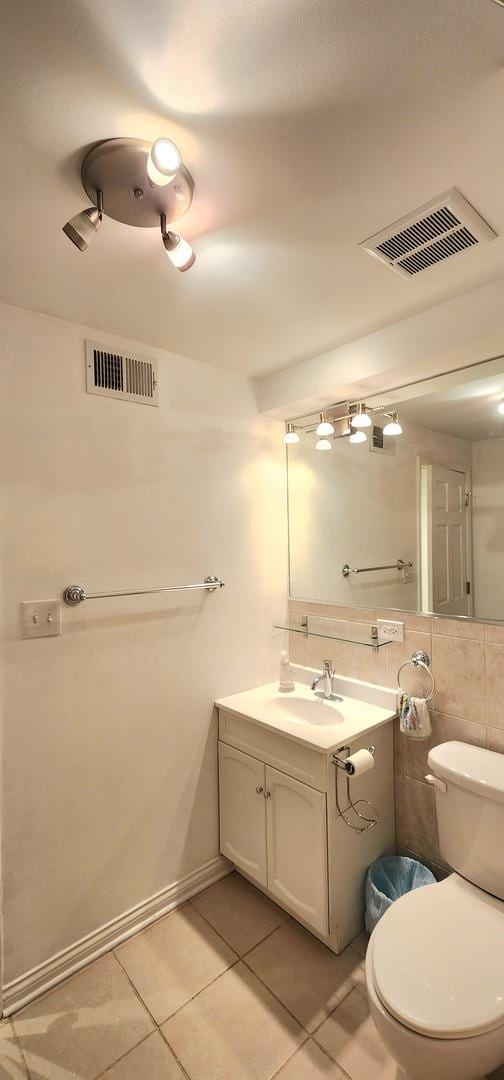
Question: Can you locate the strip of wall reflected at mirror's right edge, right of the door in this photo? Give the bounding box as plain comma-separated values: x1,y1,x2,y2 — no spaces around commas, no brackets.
473,438,504,619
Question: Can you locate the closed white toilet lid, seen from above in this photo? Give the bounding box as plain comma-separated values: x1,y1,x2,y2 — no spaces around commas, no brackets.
372,874,504,1039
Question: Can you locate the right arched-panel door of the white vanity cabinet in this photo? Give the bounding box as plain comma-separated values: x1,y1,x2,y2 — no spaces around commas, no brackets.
265,766,329,934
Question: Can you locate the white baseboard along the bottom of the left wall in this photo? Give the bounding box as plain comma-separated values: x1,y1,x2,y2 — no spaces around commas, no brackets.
3,855,232,1016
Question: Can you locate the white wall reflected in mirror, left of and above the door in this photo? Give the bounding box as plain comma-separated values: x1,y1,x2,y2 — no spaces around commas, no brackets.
289,421,471,611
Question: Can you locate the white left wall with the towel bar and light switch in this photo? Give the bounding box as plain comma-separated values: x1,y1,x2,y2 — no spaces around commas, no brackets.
0,306,286,982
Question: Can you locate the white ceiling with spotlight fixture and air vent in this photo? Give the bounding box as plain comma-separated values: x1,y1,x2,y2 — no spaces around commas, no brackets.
0,0,504,375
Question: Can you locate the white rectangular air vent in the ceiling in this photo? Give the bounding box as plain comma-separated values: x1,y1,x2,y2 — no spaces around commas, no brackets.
359,188,495,278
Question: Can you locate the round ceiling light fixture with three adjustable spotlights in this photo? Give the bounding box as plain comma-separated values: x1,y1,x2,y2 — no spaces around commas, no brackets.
63,138,195,271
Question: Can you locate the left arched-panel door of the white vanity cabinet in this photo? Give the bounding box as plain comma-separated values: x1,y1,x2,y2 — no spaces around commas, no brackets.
219,742,267,886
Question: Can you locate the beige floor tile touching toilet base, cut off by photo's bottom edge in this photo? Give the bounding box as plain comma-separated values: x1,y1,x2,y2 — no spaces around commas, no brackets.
315,989,406,1080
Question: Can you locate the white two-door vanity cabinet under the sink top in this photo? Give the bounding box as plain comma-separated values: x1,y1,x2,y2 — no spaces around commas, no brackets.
219,691,395,953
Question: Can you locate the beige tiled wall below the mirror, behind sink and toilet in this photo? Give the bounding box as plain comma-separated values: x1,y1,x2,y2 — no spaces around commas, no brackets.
288,600,504,872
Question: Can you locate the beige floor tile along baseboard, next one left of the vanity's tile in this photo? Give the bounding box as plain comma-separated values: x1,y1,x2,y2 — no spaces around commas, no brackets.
117,904,236,1024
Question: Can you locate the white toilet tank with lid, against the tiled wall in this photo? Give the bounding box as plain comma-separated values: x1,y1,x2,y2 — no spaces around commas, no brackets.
426,742,504,900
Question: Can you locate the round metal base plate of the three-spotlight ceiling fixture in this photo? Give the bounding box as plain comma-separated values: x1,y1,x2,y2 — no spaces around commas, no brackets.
81,138,194,229
